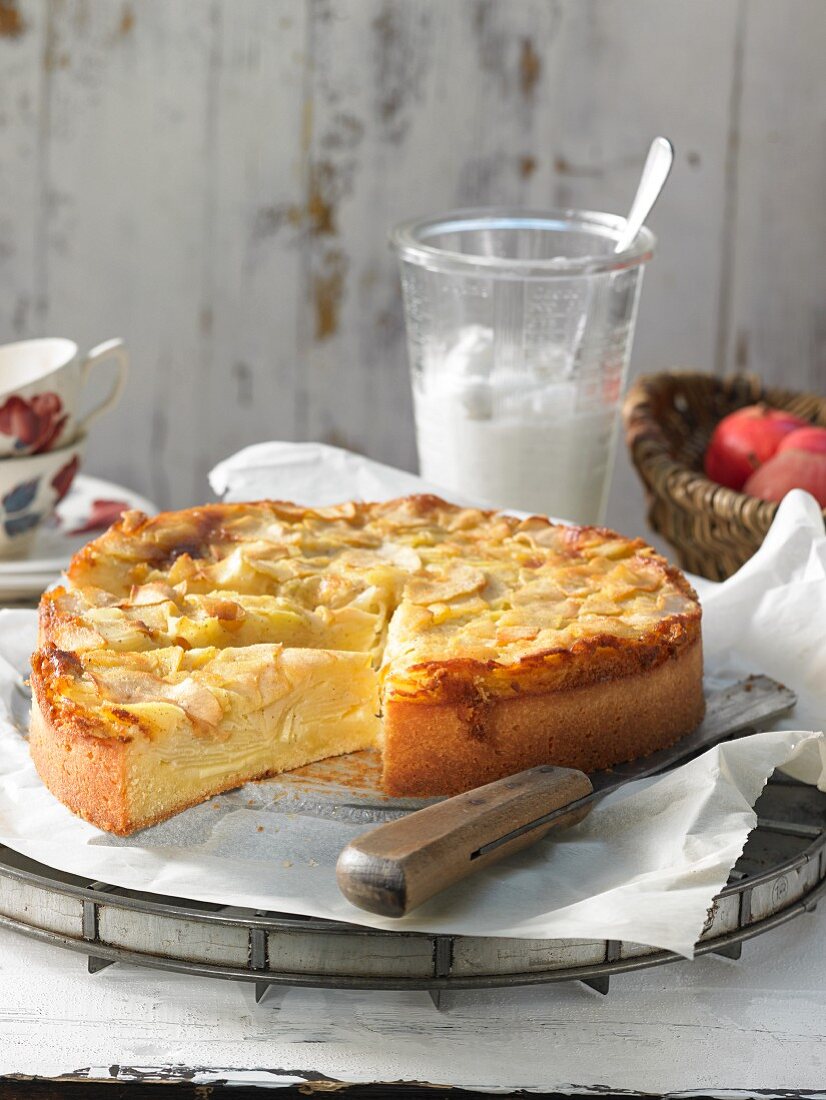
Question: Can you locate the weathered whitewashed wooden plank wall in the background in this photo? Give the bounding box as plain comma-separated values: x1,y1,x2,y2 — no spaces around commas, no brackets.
0,0,826,530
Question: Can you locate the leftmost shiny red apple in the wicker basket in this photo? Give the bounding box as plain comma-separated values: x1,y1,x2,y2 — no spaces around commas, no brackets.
704,405,806,490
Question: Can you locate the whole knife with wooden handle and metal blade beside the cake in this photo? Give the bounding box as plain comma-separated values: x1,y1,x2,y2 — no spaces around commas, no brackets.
335,677,797,917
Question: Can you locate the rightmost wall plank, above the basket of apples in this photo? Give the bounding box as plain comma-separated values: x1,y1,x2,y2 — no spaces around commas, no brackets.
722,0,826,394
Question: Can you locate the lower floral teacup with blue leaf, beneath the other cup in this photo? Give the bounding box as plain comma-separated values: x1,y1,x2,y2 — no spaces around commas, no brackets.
0,436,86,558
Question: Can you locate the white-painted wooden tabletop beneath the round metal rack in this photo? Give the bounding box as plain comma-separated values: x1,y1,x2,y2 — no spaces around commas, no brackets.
0,906,826,1097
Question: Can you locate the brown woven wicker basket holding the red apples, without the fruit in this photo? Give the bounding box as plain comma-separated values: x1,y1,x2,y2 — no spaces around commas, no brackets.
623,371,826,581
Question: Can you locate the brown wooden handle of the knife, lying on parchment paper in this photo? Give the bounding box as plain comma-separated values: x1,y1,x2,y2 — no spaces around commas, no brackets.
335,765,593,916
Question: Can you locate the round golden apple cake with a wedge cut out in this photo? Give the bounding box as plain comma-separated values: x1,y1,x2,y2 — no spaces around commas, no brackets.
30,496,704,834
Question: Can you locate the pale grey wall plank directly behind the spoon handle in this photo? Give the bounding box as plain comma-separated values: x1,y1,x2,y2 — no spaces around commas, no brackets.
545,0,737,373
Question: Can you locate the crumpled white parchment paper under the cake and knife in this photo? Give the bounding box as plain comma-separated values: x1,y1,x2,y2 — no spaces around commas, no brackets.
0,444,826,956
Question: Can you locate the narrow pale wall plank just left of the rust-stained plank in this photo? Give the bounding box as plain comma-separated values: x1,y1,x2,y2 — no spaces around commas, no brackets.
185,0,308,498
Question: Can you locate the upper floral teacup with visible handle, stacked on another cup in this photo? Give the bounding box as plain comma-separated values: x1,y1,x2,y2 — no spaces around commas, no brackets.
0,338,129,459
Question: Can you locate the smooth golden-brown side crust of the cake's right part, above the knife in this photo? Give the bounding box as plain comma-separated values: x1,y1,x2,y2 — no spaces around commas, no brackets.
383,641,705,798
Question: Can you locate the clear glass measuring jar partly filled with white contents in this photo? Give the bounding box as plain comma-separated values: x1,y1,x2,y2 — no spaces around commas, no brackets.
393,210,654,524
